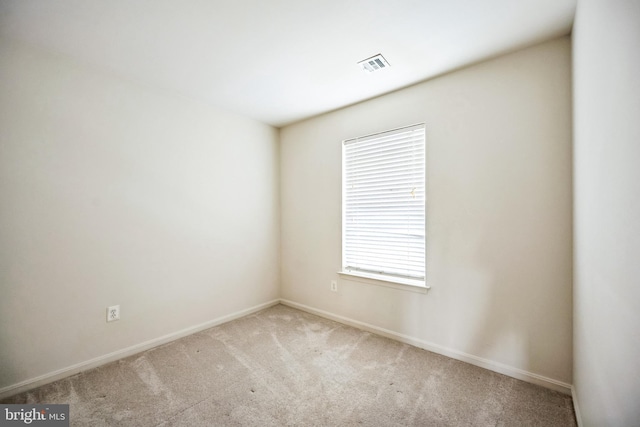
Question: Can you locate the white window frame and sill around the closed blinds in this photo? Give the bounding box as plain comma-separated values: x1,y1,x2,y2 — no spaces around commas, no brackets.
338,122,430,292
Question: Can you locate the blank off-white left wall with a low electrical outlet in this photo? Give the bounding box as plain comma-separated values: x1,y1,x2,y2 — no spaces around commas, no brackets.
0,40,279,389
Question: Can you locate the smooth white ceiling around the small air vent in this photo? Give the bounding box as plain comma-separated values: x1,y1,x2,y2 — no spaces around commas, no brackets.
0,0,576,126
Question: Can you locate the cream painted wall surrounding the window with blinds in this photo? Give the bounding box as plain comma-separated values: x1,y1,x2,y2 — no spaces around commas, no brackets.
280,37,572,387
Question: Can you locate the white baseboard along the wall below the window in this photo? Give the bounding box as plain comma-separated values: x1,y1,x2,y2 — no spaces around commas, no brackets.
280,299,571,395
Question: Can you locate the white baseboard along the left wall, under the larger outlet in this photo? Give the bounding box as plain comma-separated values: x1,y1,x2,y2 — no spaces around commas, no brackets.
0,299,280,399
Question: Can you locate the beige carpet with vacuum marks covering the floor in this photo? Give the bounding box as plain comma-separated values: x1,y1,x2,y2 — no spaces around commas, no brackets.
2,305,575,426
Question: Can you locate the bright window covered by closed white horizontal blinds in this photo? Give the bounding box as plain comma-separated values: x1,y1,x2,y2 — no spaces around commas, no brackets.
342,124,426,287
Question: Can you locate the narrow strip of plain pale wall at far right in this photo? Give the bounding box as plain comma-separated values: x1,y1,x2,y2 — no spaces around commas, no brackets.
573,0,640,427
